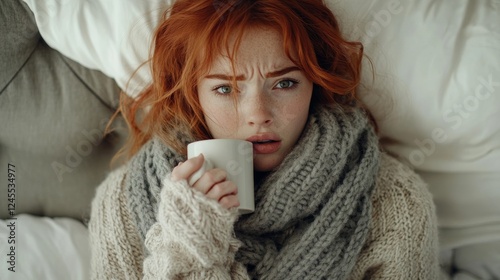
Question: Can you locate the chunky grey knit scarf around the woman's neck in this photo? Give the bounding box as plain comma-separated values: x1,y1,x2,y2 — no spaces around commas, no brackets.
125,104,379,280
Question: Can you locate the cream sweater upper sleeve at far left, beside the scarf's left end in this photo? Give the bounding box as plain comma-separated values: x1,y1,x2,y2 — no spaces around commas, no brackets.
89,167,144,279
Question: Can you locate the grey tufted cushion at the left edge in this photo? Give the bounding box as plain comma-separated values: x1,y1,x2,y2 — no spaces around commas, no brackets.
0,0,126,223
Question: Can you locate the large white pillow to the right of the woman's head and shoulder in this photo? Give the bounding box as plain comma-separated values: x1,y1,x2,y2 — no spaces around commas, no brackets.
328,0,500,248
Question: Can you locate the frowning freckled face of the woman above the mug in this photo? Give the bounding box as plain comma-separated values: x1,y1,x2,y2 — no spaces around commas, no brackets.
198,28,313,171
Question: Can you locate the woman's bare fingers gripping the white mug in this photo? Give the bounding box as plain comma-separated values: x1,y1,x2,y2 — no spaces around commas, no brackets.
172,154,240,209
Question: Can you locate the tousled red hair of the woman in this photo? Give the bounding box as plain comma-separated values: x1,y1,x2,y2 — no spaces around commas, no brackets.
119,0,363,157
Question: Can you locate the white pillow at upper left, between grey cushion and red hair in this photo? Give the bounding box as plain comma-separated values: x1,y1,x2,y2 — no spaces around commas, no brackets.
24,0,172,96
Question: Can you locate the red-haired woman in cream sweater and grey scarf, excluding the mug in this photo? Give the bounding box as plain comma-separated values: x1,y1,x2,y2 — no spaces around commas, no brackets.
90,0,438,279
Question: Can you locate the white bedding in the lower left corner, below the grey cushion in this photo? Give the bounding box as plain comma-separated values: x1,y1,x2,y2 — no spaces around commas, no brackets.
0,214,90,280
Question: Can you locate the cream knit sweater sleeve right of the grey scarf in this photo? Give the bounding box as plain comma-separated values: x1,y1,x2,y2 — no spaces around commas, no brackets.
351,155,441,280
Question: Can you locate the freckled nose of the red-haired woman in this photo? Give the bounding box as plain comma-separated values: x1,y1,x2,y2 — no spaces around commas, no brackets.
240,93,273,126
